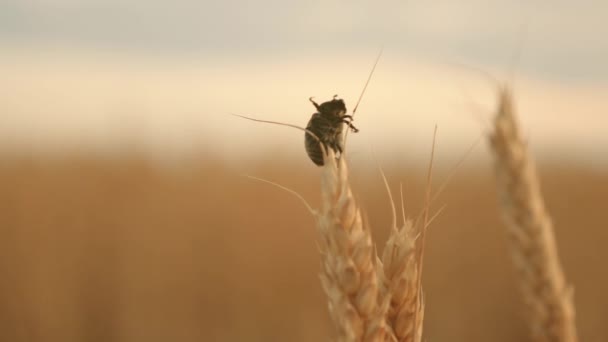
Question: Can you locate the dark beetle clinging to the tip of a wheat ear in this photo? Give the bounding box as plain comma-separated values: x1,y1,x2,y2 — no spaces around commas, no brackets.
304,95,359,166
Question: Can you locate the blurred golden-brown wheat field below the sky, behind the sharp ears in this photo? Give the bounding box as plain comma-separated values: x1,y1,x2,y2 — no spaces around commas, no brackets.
0,154,608,341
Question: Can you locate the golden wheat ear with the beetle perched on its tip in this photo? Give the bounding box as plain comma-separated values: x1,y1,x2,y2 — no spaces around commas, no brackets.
318,150,394,341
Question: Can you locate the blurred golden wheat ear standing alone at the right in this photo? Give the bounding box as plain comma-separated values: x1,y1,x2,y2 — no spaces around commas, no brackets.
489,87,577,342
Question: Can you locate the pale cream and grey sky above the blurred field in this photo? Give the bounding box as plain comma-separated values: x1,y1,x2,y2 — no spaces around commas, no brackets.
0,0,608,166
